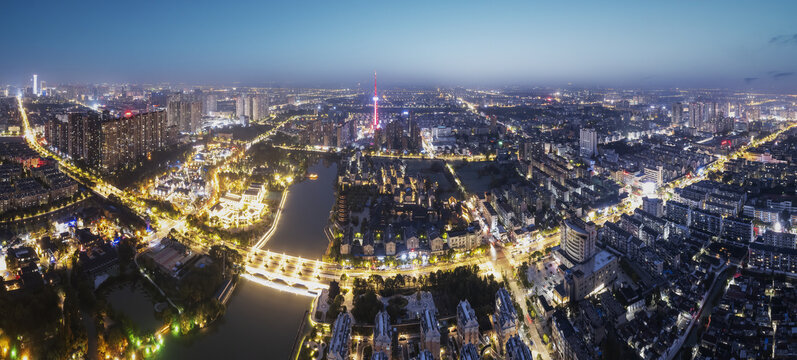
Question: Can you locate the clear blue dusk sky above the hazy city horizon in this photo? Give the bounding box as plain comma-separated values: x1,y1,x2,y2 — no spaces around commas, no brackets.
0,0,797,91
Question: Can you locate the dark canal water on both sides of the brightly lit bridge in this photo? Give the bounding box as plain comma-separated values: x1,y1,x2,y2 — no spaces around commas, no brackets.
159,161,337,360
